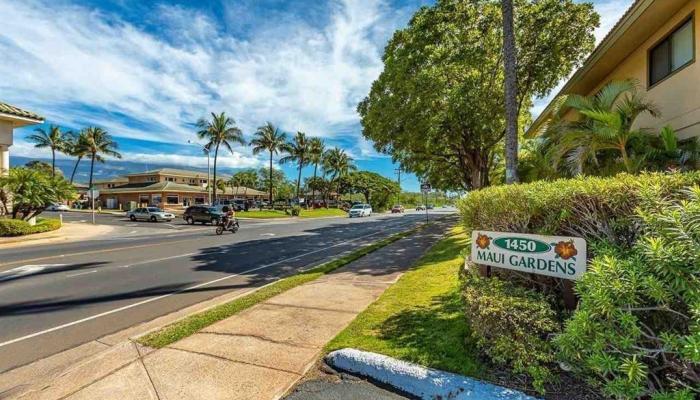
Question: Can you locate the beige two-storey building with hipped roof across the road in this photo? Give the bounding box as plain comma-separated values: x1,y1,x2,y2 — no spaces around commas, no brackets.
94,168,266,210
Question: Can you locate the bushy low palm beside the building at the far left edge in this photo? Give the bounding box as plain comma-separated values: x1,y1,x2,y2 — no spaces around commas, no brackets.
0,167,75,221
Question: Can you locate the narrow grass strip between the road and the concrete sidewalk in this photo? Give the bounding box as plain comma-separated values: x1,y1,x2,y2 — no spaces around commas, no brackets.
137,227,420,348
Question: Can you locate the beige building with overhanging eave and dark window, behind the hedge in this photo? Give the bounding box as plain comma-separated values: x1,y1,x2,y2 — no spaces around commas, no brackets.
528,0,700,139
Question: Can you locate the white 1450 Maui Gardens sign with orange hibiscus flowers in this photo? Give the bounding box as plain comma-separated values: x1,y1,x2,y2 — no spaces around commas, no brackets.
471,230,586,280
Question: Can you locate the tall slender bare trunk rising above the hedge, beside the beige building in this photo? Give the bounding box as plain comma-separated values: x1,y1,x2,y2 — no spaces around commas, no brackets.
501,0,518,184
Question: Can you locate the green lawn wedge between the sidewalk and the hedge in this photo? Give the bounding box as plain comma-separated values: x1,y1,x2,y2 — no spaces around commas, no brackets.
326,228,482,376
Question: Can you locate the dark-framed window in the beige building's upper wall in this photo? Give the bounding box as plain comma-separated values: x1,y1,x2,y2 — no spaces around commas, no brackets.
649,17,695,86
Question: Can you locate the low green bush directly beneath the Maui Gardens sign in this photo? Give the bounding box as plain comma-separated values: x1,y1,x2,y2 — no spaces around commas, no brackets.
462,271,560,393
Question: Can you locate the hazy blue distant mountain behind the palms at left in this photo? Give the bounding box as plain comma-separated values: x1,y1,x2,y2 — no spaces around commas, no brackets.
10,156,242,184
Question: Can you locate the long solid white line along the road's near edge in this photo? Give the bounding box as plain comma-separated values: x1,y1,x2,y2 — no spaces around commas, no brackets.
0,220,416,347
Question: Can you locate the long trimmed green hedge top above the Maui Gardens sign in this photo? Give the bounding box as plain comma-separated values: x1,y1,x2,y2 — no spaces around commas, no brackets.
458,172,700,245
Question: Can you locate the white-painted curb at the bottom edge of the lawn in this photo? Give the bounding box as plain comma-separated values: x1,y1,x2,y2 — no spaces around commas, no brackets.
325,349,537,400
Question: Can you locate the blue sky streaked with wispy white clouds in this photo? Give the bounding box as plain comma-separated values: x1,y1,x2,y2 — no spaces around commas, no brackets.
0,0,632,190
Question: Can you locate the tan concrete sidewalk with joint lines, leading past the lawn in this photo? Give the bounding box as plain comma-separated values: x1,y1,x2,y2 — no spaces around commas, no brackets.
9,218,454,400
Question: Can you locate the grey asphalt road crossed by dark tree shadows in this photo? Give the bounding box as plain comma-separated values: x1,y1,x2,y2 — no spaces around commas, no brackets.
0,210,450,372
